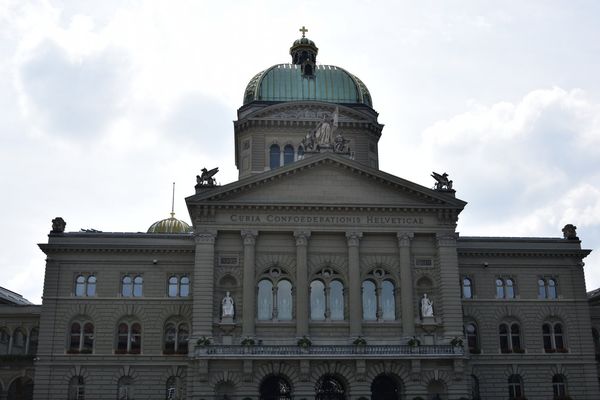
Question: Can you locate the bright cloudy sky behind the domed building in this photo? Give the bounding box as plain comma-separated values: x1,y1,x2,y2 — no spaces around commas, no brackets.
0,0,600,303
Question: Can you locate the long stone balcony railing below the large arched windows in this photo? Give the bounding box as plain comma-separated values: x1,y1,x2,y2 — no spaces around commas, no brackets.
192,345,465,359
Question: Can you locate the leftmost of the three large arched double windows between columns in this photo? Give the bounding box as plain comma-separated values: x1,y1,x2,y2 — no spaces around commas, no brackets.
256,266,293,321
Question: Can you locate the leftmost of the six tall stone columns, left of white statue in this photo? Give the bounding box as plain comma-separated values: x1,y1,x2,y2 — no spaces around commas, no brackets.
192,231,217,337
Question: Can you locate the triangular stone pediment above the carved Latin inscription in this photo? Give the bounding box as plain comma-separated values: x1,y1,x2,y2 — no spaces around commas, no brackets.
187,153,466,209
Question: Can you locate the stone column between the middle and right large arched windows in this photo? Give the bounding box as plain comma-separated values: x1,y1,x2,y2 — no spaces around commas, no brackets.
346,232,362,337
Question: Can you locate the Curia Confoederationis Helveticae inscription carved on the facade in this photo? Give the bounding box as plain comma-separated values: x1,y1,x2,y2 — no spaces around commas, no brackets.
229,214,425,225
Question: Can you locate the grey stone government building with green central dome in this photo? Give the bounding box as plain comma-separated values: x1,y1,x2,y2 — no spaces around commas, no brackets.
0,29,600,400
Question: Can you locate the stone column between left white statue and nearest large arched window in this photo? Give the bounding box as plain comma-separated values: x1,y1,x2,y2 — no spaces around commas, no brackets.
241,230,258,337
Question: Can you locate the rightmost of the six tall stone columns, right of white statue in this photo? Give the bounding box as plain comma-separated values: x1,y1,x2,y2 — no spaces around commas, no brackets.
433,232,463,337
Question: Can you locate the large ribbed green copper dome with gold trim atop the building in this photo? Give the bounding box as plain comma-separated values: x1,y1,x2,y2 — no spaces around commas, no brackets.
244,63,373,107
